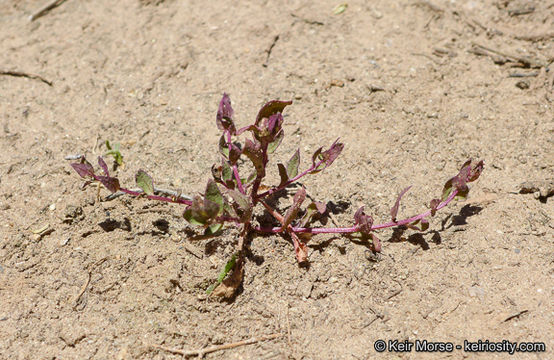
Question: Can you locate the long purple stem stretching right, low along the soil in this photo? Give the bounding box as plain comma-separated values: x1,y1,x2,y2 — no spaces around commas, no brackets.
254,189,458,234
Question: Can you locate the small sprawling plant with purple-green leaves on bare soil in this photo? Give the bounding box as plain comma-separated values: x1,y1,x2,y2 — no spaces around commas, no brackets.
71,94,483,297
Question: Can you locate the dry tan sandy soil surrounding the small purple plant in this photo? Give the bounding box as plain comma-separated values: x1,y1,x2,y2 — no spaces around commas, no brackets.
0,0,554,359
